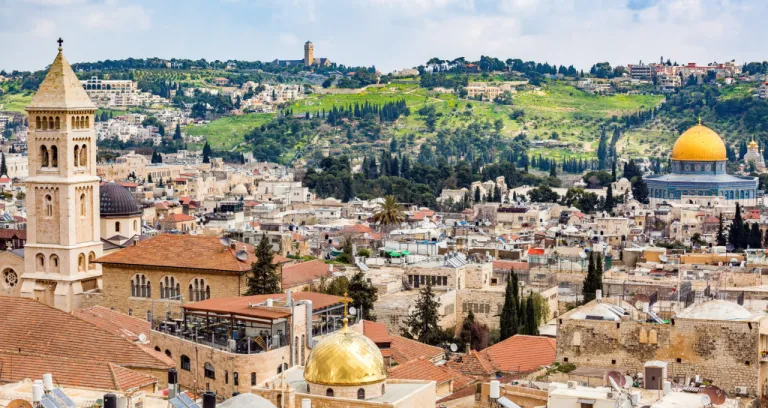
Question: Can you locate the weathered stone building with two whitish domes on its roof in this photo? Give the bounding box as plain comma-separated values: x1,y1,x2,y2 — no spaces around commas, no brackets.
557,296,768,397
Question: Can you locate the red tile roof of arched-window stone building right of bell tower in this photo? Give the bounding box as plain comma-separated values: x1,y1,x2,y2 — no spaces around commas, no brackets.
96,234,288,273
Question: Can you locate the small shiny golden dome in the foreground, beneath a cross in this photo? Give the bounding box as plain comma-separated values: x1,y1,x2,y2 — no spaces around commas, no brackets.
304,327,387,386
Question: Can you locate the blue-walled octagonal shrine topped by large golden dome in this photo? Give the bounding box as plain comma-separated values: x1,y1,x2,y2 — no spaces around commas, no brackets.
645,123,758,206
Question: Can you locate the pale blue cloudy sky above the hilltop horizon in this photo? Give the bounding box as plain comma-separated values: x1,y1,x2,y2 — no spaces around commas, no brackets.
0,0,768,72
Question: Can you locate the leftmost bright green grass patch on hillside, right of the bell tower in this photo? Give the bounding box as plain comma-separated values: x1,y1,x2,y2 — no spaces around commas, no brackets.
185,113,274,150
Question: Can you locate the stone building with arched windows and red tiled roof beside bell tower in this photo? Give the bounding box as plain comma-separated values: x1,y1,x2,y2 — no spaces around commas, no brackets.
96,234,288,319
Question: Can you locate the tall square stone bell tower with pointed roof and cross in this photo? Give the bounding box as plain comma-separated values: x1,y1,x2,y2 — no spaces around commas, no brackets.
21,38,102,311
